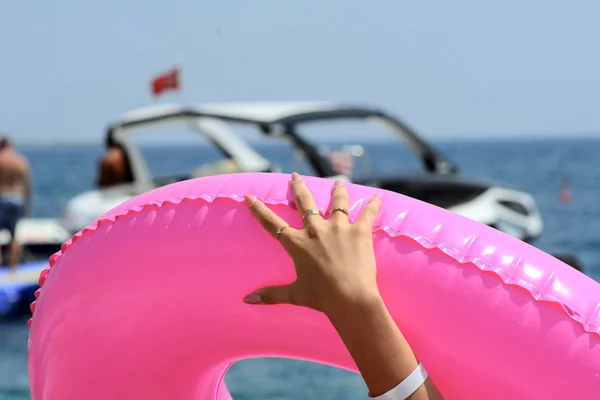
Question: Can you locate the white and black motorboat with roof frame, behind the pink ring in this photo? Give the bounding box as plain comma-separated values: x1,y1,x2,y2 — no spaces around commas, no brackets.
61,102,543,241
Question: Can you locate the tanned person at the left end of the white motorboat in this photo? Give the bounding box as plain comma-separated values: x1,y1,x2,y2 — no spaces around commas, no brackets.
96,135,133,188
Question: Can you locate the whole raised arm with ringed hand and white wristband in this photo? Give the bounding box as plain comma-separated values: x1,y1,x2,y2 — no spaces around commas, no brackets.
243,173,442,400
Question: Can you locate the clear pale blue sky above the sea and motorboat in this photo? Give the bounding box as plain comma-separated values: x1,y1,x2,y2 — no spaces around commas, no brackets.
0,0,600,142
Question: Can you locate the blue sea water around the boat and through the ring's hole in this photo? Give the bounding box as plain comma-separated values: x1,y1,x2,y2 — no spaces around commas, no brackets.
0,139,600,400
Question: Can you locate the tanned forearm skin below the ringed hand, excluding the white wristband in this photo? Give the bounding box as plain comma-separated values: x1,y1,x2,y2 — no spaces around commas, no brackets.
326,294,441,400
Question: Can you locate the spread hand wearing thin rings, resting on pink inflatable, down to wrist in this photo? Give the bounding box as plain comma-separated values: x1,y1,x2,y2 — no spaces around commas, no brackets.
244,173,381,313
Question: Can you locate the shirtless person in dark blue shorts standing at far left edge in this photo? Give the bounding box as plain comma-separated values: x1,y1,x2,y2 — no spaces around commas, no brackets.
0,136,32,270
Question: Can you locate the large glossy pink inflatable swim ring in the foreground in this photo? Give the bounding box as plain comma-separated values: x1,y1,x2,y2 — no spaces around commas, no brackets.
29,174,600,400
